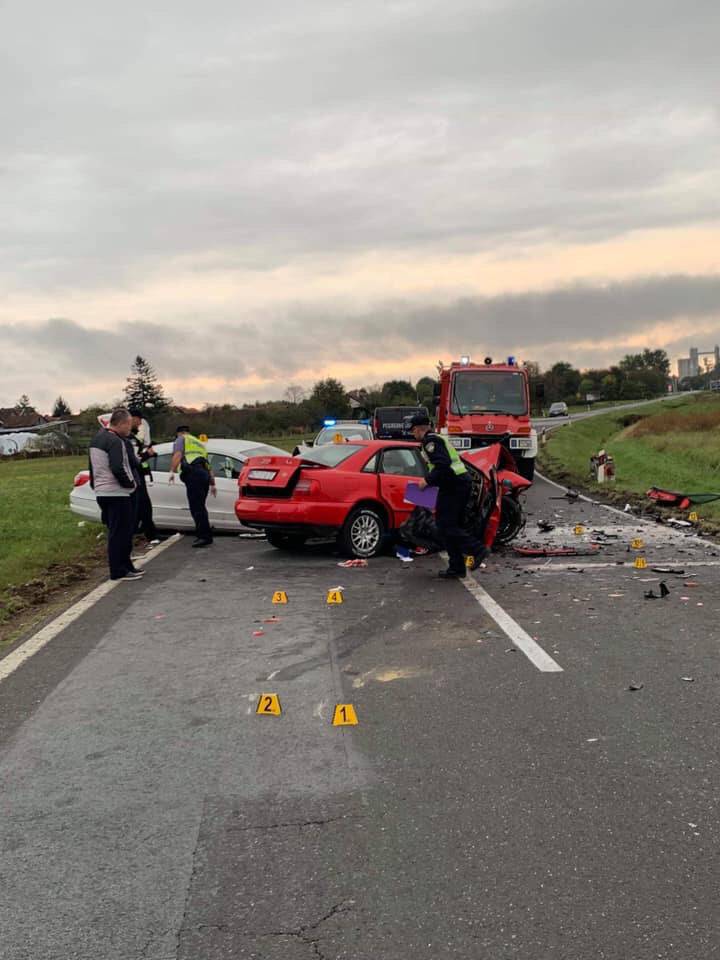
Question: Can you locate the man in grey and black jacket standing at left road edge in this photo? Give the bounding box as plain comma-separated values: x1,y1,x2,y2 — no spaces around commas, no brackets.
90,408,142,580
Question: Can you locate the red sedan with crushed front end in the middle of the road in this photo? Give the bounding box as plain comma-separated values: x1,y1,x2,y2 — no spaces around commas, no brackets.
235,440,529,558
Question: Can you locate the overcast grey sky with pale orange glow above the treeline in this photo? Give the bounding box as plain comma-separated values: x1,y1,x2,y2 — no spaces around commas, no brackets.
0,0,720,409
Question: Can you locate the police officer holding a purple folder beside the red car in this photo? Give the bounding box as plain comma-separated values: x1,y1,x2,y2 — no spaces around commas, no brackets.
410,413,487,580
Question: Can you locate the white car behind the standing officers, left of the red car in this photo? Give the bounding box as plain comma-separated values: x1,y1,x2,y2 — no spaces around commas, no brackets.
70,440,288,533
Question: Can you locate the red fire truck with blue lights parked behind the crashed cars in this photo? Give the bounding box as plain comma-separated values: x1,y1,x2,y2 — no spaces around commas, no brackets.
435,356,537,480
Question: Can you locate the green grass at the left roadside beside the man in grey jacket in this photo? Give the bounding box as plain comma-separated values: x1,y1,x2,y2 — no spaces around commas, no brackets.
0,457,105,639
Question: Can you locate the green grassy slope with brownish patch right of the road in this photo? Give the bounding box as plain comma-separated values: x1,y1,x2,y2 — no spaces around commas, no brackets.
539,393,720,522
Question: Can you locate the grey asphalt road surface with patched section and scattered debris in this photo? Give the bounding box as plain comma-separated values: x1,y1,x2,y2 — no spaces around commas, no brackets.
0,474,720,960
